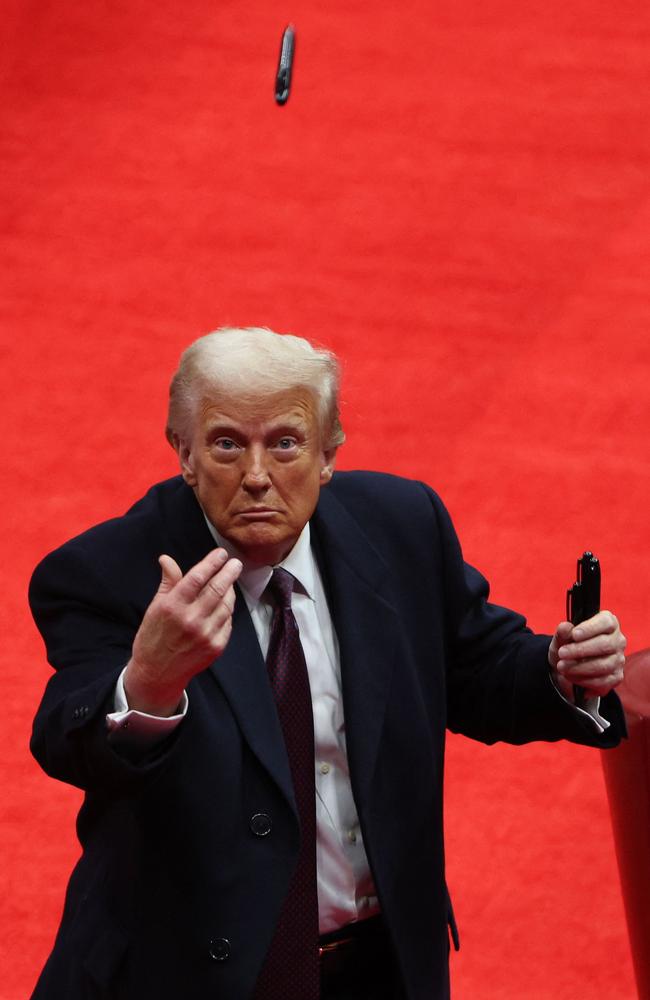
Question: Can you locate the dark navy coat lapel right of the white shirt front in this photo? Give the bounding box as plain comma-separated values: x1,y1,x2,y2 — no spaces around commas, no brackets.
312,488,399,808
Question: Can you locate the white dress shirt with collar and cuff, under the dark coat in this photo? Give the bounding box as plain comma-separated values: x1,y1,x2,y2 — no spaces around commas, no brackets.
107,519,379,934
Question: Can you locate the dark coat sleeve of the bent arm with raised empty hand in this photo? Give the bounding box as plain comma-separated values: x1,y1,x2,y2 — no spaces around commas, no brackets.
29,542,180,792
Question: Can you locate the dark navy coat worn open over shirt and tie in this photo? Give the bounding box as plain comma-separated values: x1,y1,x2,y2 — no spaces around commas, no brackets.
30,473,624,1000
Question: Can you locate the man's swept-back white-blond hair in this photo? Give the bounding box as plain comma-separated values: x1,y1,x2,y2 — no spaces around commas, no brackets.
166,327,345,448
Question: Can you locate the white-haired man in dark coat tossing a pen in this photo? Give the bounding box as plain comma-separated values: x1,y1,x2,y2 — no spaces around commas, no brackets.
30,330,625,1000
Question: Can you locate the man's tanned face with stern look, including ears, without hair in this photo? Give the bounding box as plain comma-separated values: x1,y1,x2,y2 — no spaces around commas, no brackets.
176,388,336,565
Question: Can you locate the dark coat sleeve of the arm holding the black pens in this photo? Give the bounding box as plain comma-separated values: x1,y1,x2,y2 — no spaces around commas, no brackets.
427,488,625,748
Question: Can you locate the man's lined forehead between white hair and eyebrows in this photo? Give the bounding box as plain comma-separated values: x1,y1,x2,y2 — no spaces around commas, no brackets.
197,386,318,430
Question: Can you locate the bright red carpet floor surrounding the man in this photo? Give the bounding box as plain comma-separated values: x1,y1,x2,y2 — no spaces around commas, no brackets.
0,0,650,1000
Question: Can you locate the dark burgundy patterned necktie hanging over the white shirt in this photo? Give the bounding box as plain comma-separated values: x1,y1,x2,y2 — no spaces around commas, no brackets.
254,569,320,1000
